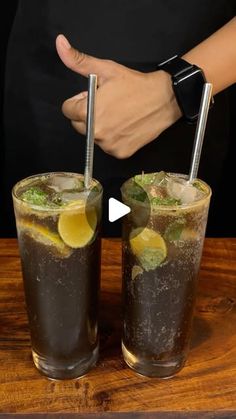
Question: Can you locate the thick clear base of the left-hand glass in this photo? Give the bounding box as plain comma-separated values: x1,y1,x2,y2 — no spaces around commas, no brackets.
32,346,99,380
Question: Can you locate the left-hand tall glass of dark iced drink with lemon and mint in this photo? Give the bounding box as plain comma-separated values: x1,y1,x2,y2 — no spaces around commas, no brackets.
13,173,102,379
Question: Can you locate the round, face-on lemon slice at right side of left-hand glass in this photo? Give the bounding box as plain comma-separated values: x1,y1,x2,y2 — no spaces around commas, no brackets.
58,201,97,249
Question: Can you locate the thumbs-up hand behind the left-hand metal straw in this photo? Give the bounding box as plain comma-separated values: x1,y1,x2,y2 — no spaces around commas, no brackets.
56,35,181,159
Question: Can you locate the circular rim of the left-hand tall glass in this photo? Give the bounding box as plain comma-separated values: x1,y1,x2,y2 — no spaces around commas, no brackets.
11,171,103,213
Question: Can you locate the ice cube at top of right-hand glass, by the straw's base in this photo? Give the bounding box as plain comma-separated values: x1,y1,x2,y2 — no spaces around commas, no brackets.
167,176,198,204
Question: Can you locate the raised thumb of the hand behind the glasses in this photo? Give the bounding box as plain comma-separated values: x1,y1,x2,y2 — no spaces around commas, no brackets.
56,35,113,82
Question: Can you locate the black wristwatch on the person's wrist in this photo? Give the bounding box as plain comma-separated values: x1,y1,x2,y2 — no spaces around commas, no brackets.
158,55,206,123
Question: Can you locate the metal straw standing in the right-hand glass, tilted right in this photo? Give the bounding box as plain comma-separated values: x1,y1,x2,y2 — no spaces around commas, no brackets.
189,83,212,182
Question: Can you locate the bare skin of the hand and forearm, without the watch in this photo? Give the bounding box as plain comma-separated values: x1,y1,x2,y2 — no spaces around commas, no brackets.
56,18,236,158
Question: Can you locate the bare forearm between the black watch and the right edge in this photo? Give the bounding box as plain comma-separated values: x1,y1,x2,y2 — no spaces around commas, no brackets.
183,17,236,94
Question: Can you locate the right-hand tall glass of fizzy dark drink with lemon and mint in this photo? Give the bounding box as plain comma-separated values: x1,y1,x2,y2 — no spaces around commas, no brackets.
122,172,211,378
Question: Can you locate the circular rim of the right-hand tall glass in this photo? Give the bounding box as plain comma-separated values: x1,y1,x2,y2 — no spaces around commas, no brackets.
121,172,212,211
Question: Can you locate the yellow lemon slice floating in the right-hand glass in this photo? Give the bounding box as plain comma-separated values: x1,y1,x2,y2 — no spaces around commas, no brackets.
129,228,167,271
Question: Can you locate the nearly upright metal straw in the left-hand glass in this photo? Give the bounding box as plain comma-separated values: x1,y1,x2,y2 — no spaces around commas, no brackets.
84,74,97,189
